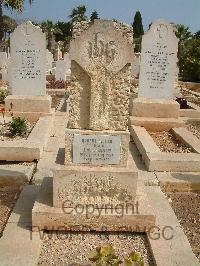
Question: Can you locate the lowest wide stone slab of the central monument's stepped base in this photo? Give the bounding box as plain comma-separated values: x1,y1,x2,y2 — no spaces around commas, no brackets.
32,178,155,232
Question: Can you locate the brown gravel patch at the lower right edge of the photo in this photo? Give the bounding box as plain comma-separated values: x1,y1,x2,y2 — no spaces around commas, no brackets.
167,192,200,261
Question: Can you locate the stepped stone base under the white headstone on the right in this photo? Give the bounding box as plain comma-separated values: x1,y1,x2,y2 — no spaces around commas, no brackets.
129,98,184,131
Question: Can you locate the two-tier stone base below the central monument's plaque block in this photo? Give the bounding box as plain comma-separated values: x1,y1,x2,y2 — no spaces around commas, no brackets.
32,154,155,232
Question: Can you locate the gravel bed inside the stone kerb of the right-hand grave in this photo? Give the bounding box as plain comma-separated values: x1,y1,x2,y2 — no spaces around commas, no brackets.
149,131,192,153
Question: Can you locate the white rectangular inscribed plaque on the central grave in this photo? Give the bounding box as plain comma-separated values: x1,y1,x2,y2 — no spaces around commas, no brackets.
73,134,121,165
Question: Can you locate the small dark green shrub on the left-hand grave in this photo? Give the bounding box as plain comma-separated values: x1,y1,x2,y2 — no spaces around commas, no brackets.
8,117,27,136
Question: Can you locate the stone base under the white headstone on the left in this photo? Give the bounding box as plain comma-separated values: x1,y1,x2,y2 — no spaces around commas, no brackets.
5,95,52,122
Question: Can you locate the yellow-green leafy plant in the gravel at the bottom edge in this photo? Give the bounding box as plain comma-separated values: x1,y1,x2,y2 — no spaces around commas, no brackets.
88,244,144,266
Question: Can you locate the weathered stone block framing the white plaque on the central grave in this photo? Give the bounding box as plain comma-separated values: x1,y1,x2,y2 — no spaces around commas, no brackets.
65,129,130,166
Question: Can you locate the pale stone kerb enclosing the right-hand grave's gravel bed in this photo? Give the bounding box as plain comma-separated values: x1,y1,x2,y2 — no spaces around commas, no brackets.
130,126,200,172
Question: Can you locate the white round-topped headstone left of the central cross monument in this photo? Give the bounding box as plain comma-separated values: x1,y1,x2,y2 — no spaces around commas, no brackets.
10,21,46,96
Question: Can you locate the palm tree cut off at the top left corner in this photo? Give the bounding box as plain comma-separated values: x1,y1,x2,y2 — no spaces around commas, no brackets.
0,0,33,42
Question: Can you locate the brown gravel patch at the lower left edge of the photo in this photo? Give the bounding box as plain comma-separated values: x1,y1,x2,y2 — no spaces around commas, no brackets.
0,188,20,237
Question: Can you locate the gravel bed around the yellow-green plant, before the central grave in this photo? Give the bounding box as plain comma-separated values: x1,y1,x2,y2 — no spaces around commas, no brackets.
38,232,154,266
